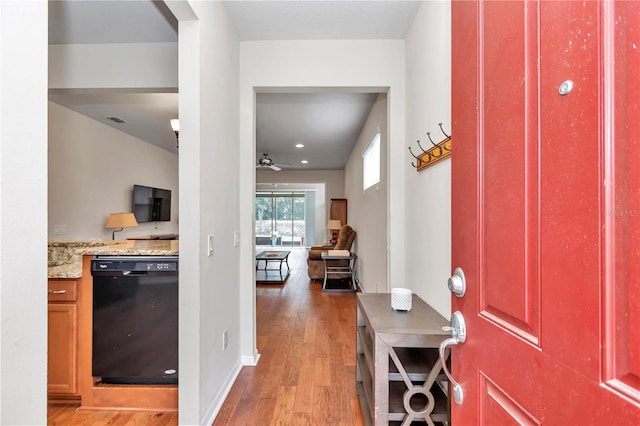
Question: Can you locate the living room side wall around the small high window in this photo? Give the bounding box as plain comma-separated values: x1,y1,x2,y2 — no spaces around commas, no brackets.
345,93,390,293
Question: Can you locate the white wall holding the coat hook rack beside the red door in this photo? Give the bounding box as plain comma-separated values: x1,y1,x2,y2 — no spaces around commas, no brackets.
404,1,456,318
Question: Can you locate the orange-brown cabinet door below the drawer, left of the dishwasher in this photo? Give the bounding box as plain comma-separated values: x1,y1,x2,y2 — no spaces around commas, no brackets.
47,303,78,394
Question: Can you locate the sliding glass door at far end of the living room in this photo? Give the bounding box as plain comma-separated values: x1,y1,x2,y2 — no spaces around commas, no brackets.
255,192,305,246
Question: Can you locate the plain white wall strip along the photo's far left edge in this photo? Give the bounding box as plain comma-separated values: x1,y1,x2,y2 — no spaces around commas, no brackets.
0,0,48,425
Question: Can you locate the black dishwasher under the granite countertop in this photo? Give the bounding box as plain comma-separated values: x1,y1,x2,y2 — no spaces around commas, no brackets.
91,256,178,384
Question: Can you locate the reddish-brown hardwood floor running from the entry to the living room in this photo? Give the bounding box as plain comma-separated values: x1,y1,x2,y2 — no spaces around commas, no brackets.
48,248,364,426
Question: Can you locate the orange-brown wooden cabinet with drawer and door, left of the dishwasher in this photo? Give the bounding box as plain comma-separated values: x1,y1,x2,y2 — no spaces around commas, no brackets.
47,279,78,397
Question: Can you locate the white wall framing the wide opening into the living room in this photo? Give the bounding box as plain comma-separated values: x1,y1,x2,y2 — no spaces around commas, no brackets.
239,40,407,360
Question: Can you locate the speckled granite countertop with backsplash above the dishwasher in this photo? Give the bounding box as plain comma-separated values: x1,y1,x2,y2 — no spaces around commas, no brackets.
48,240,178,278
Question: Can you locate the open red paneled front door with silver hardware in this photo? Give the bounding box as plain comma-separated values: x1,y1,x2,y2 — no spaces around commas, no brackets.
452,1,640,425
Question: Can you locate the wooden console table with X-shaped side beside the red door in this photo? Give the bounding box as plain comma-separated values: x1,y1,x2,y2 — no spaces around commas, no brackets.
356,293,450,425
